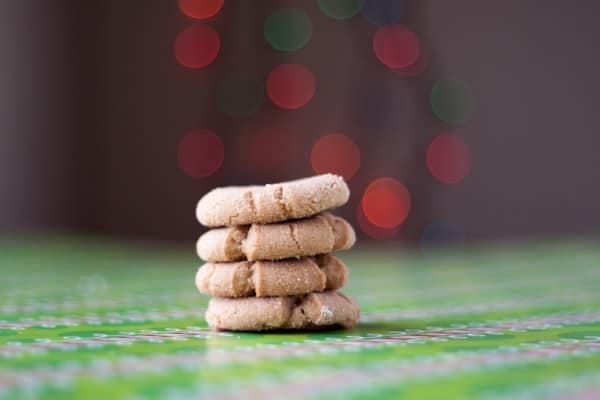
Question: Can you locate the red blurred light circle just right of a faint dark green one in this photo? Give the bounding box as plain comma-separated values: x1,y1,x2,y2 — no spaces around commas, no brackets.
266,63,317,110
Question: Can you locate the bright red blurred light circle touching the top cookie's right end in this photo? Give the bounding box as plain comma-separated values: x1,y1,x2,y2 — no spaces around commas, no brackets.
310,133,360,180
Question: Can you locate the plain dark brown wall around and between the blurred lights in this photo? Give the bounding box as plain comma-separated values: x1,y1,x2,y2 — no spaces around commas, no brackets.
0,0,600,239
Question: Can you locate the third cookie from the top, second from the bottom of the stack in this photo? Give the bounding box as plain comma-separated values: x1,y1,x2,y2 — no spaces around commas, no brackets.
196,254,348,297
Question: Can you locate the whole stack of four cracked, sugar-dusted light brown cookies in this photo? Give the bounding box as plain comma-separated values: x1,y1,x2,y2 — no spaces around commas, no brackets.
196,174,359,331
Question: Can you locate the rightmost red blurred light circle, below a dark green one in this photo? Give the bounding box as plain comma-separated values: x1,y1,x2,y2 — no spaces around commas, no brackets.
427,133,471,183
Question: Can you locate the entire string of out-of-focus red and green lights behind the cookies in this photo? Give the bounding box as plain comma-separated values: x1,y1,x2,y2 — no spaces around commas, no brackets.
174,0,475,247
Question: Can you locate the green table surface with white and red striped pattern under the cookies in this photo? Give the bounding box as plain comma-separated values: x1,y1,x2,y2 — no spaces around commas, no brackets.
0,238,600,400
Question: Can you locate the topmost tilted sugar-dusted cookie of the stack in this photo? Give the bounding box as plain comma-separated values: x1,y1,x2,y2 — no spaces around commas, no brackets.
196,174,350,227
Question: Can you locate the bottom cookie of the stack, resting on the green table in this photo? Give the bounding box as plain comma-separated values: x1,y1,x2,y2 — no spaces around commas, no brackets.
206,291,359,331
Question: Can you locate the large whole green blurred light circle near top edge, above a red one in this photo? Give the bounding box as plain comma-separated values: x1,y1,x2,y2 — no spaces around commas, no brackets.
264,8,312,51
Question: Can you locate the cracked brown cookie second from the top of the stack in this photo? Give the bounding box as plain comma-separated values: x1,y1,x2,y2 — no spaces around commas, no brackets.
196,213,356,262
